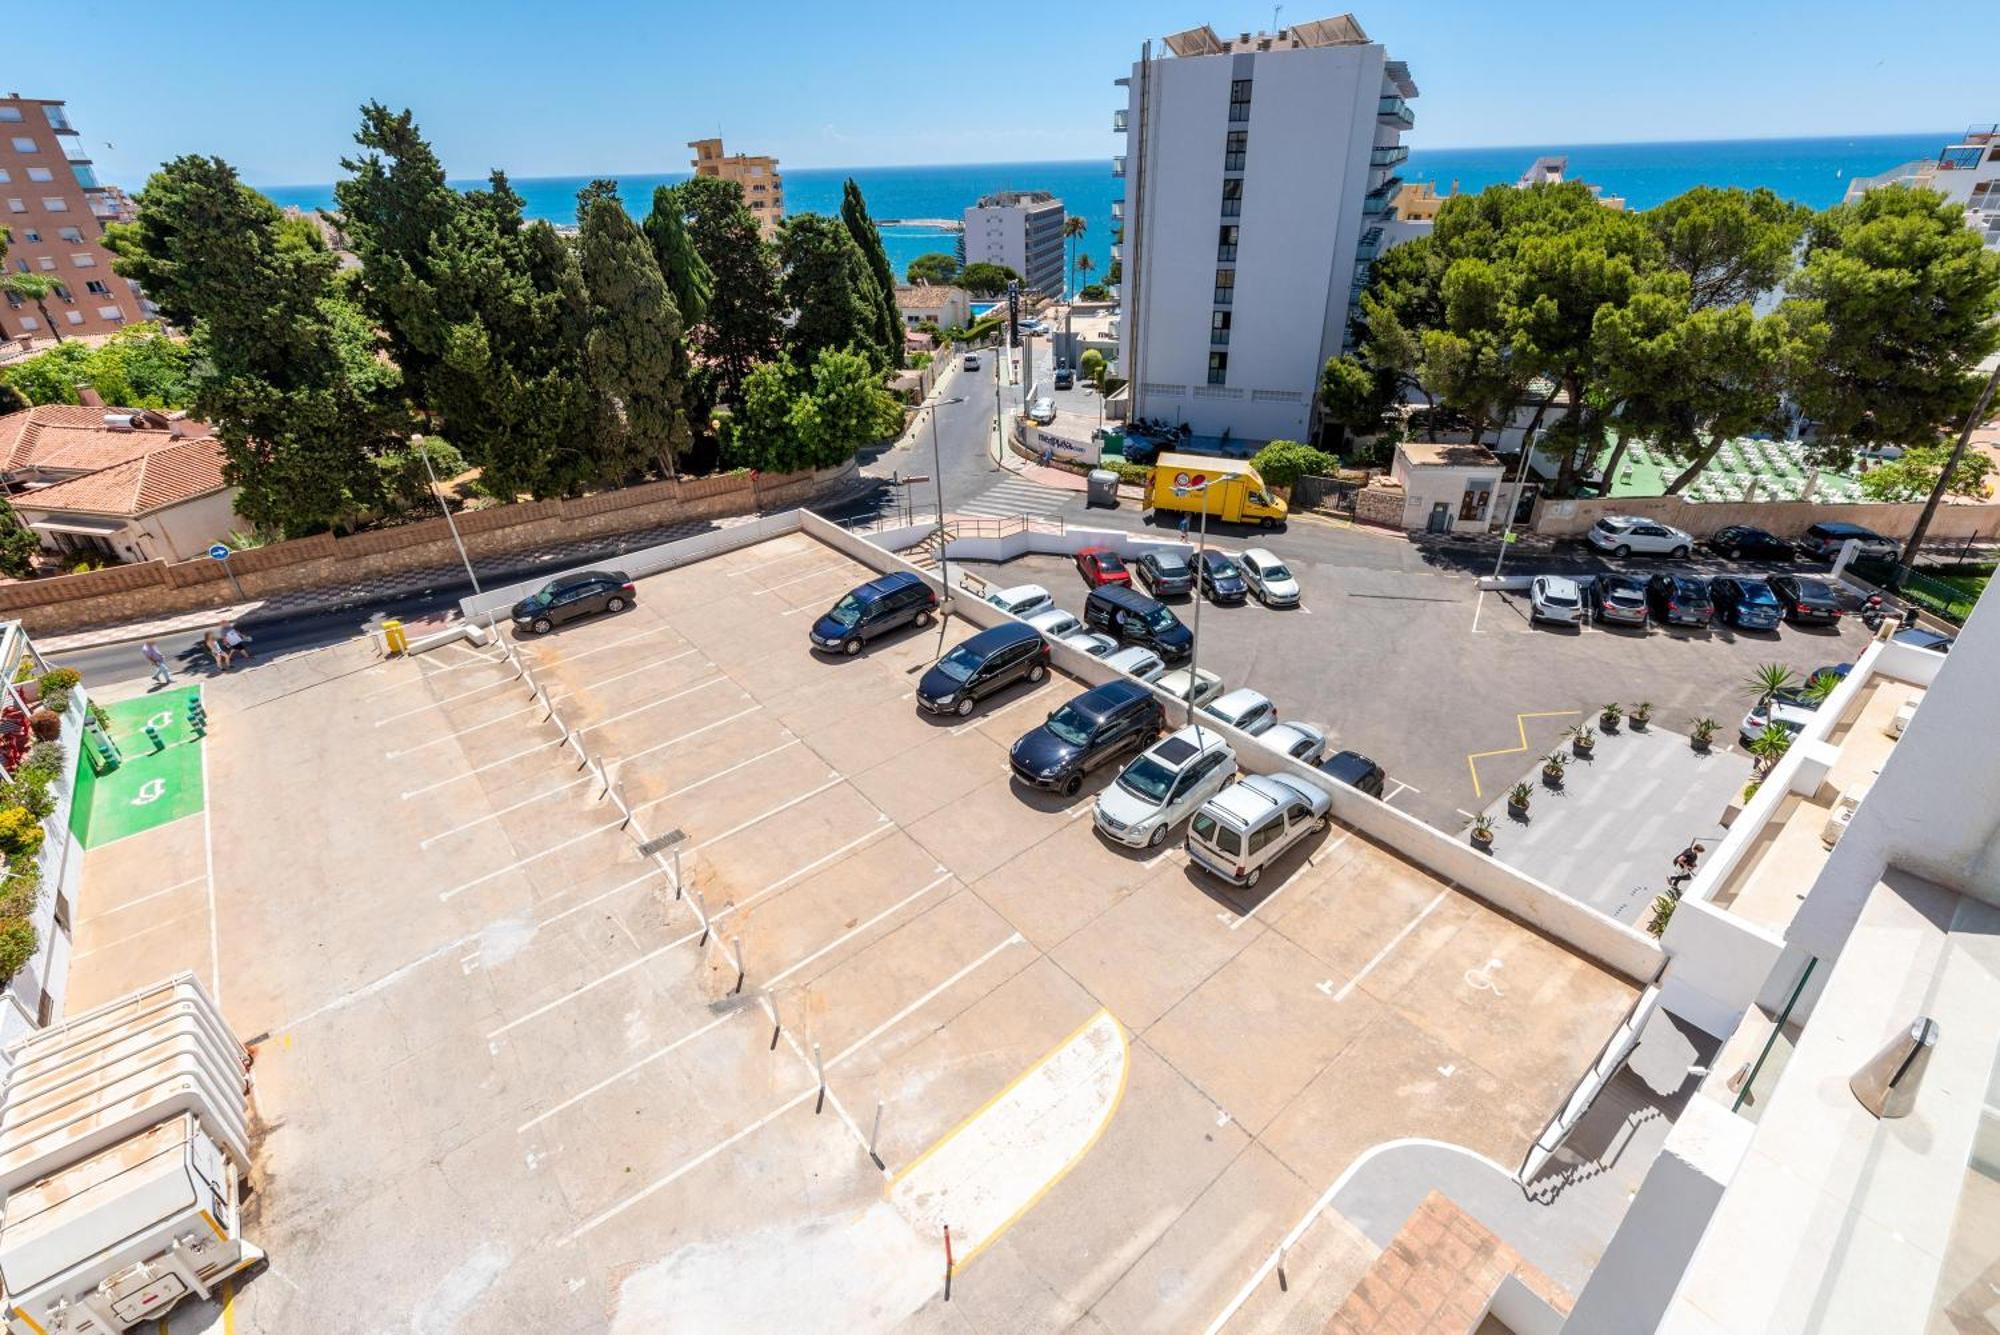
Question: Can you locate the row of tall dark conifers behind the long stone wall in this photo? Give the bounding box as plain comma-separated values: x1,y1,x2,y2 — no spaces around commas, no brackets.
106,104,902,534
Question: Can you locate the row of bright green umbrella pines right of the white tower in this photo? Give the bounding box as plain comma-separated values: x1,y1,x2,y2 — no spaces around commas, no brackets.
1320,184,2000,503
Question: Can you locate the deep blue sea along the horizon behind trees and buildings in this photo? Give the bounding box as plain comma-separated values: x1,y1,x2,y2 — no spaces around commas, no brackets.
264,132,1954,293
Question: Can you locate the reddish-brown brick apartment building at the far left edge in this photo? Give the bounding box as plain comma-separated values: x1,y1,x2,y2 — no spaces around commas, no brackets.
0,94,152,346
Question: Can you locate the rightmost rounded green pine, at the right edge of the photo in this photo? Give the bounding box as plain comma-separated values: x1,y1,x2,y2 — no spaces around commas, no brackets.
1784,186,2000,466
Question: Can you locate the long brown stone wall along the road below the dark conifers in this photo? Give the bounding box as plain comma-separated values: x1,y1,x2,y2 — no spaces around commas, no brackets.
0,464,856,636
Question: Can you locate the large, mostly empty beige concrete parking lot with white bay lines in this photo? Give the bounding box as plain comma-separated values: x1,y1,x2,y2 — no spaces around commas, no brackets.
70,534,1634,1331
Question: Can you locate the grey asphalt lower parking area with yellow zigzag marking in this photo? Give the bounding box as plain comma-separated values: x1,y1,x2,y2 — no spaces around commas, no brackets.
954,539,1868,835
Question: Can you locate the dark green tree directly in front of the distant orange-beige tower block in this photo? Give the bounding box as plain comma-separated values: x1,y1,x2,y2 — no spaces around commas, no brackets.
674,176,784,408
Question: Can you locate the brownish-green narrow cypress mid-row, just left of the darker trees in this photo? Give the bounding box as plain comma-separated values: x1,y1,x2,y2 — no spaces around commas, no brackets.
576,182,690,480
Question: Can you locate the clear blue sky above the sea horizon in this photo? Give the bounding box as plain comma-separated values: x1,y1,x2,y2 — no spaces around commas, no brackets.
4,0,2000,188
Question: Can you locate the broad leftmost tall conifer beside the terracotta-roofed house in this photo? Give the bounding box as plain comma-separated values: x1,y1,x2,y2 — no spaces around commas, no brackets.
116,156,408,536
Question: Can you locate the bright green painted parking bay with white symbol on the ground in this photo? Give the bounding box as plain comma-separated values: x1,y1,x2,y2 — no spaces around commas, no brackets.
70,685,208,847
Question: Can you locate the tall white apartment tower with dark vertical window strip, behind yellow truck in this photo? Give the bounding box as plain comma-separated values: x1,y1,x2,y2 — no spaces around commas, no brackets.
1112,14,1416,440
